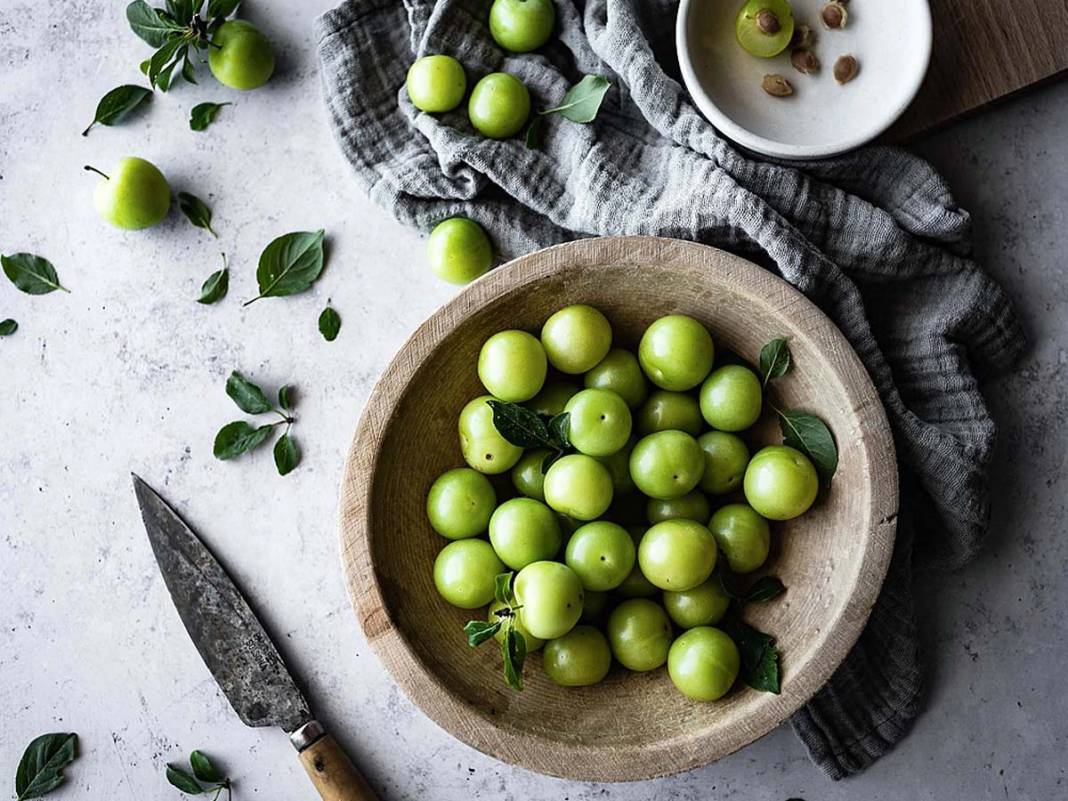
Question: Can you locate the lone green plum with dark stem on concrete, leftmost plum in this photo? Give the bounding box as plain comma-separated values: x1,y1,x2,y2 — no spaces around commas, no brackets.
85,156,171,231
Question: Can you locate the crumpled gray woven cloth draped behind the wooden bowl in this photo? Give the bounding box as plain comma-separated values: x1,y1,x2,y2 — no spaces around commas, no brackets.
317,0,1024,779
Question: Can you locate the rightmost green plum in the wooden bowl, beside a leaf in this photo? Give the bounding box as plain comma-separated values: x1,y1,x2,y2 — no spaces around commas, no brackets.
742,445,819,520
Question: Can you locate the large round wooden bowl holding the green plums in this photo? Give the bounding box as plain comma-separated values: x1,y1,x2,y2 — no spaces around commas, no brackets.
340,237,897,781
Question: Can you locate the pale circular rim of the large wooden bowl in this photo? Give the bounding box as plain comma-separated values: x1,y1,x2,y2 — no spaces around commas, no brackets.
339,236,898,781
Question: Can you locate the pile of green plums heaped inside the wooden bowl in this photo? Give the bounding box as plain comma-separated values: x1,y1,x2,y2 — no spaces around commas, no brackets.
426,304,819,701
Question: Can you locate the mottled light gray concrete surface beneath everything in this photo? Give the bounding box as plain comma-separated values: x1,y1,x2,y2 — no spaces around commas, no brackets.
0,0,1068,801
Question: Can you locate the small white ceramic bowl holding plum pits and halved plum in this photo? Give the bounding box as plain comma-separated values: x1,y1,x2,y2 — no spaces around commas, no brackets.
676,0,931,159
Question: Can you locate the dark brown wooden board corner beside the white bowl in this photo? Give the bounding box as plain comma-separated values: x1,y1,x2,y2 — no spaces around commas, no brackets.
888,0,1068,142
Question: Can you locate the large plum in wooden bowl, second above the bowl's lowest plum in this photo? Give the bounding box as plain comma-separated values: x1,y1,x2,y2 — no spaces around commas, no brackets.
638,518,717,593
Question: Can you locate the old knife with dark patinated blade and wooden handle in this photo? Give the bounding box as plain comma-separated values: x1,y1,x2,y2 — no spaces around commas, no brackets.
134,475,377,801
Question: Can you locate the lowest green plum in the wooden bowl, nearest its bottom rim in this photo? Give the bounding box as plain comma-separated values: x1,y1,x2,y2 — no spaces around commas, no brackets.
668,626,741,701
